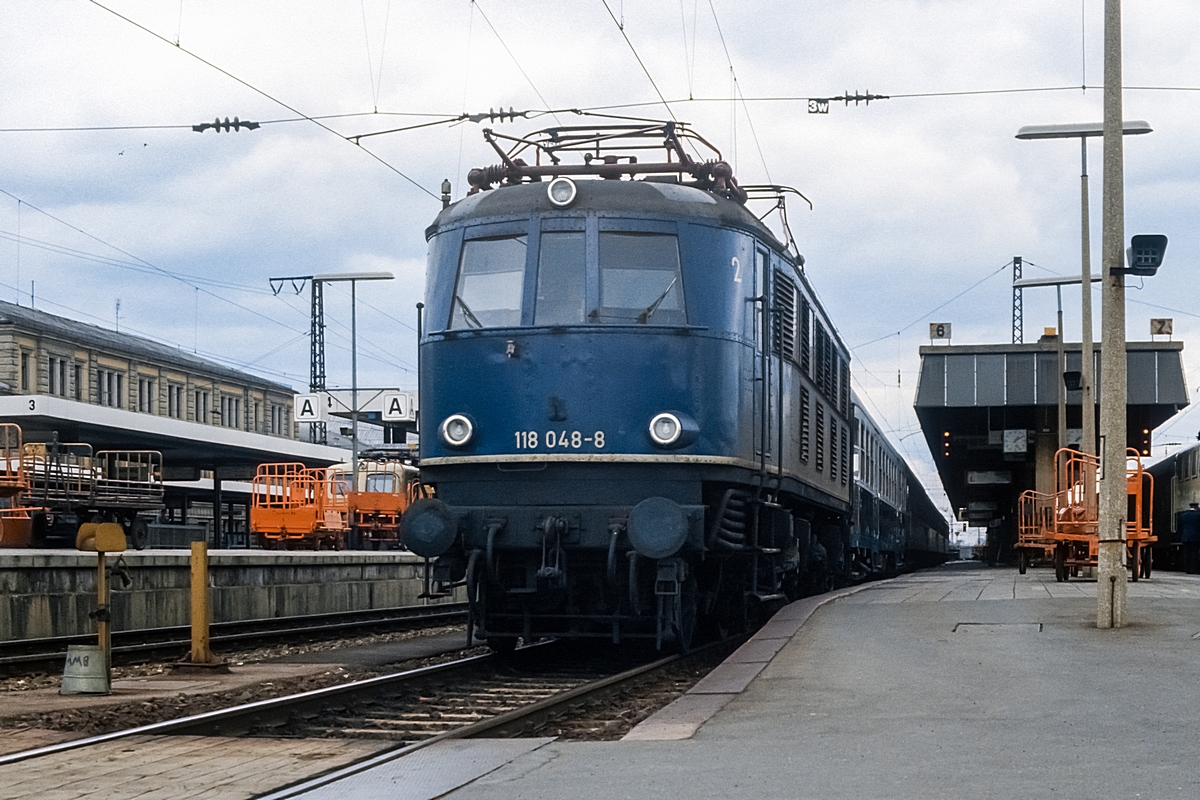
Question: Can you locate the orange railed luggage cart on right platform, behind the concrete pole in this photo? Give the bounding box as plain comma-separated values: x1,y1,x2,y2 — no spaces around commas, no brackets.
1016,447,1158,582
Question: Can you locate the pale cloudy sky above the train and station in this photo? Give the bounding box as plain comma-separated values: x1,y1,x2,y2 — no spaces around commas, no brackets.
0,0,1200,520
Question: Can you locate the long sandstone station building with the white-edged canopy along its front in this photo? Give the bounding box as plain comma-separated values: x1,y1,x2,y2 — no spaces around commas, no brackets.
0,301,347,546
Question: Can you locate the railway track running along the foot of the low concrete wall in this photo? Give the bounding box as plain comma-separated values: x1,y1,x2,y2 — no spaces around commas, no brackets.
0,603,467,674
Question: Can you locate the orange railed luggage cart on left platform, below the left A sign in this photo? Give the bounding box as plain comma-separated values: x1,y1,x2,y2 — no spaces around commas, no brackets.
250,463,349,549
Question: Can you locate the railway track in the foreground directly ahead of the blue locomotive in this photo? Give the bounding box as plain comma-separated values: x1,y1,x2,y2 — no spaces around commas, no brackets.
0,637,743,772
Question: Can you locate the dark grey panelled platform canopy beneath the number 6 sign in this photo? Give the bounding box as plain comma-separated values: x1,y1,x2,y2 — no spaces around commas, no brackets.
914,338,1188,527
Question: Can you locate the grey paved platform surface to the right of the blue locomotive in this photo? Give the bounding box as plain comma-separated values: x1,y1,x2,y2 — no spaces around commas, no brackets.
288,565,1200,800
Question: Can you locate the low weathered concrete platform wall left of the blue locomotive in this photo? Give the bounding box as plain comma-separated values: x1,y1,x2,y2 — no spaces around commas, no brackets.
0,549,464,640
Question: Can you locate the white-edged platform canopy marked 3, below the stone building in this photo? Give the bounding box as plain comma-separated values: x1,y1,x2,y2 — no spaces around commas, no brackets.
0,395,348,480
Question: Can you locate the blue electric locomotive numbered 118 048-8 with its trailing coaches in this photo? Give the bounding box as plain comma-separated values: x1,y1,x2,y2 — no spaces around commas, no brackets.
402,122,949,650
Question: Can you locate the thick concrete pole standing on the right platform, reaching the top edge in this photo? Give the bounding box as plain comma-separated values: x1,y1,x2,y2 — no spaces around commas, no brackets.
1096,0,1127,627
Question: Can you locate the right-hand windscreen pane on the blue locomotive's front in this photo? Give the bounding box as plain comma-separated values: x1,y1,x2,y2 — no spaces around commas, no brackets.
592,231,688,325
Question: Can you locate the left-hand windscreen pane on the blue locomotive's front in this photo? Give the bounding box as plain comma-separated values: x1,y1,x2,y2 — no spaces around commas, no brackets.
450,235,527,330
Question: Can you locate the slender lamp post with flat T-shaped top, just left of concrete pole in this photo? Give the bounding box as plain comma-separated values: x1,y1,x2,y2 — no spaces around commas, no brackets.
1016,120,1153,456
